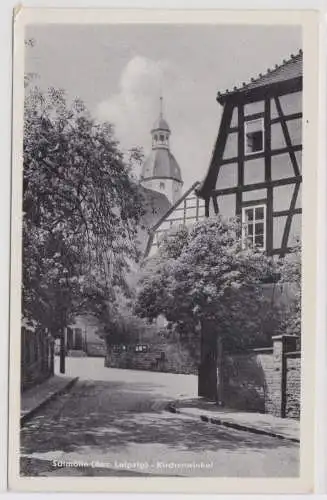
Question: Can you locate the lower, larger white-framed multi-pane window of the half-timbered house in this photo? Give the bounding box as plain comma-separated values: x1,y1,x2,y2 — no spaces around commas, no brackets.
242,205,266,250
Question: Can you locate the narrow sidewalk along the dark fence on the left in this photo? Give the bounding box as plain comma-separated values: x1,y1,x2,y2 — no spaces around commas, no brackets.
20,375,78,425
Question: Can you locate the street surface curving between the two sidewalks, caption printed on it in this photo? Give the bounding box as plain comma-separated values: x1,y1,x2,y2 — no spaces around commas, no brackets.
21,358,299,477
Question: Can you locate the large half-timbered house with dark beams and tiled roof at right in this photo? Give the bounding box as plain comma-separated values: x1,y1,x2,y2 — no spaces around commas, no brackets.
197,51,303,256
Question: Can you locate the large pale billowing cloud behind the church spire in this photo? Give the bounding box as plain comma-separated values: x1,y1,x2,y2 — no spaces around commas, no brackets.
96,56,223,188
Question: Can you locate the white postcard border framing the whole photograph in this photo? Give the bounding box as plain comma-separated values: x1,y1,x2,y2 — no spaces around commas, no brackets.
8,8,319,493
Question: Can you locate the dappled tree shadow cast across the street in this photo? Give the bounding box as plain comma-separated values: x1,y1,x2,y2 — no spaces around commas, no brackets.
21,380,298,454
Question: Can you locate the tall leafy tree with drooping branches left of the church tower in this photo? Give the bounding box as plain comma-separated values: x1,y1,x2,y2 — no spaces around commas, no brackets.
22,83,142,348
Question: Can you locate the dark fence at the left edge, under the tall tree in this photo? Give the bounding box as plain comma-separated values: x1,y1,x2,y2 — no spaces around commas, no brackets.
21,328,54,391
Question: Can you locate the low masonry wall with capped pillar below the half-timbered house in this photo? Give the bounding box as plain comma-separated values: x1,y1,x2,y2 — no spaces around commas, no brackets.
222,335,301,418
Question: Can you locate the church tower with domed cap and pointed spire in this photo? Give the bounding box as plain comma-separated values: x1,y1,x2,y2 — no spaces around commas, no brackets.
140,97,183,205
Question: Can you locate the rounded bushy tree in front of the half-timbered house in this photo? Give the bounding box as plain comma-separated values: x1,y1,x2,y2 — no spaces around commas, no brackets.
135,216,292,348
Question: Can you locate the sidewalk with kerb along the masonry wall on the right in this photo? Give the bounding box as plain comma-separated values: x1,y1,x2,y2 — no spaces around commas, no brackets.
167,398,300,443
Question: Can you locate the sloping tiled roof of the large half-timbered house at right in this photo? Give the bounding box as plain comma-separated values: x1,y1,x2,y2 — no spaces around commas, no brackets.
217,50,303,104
